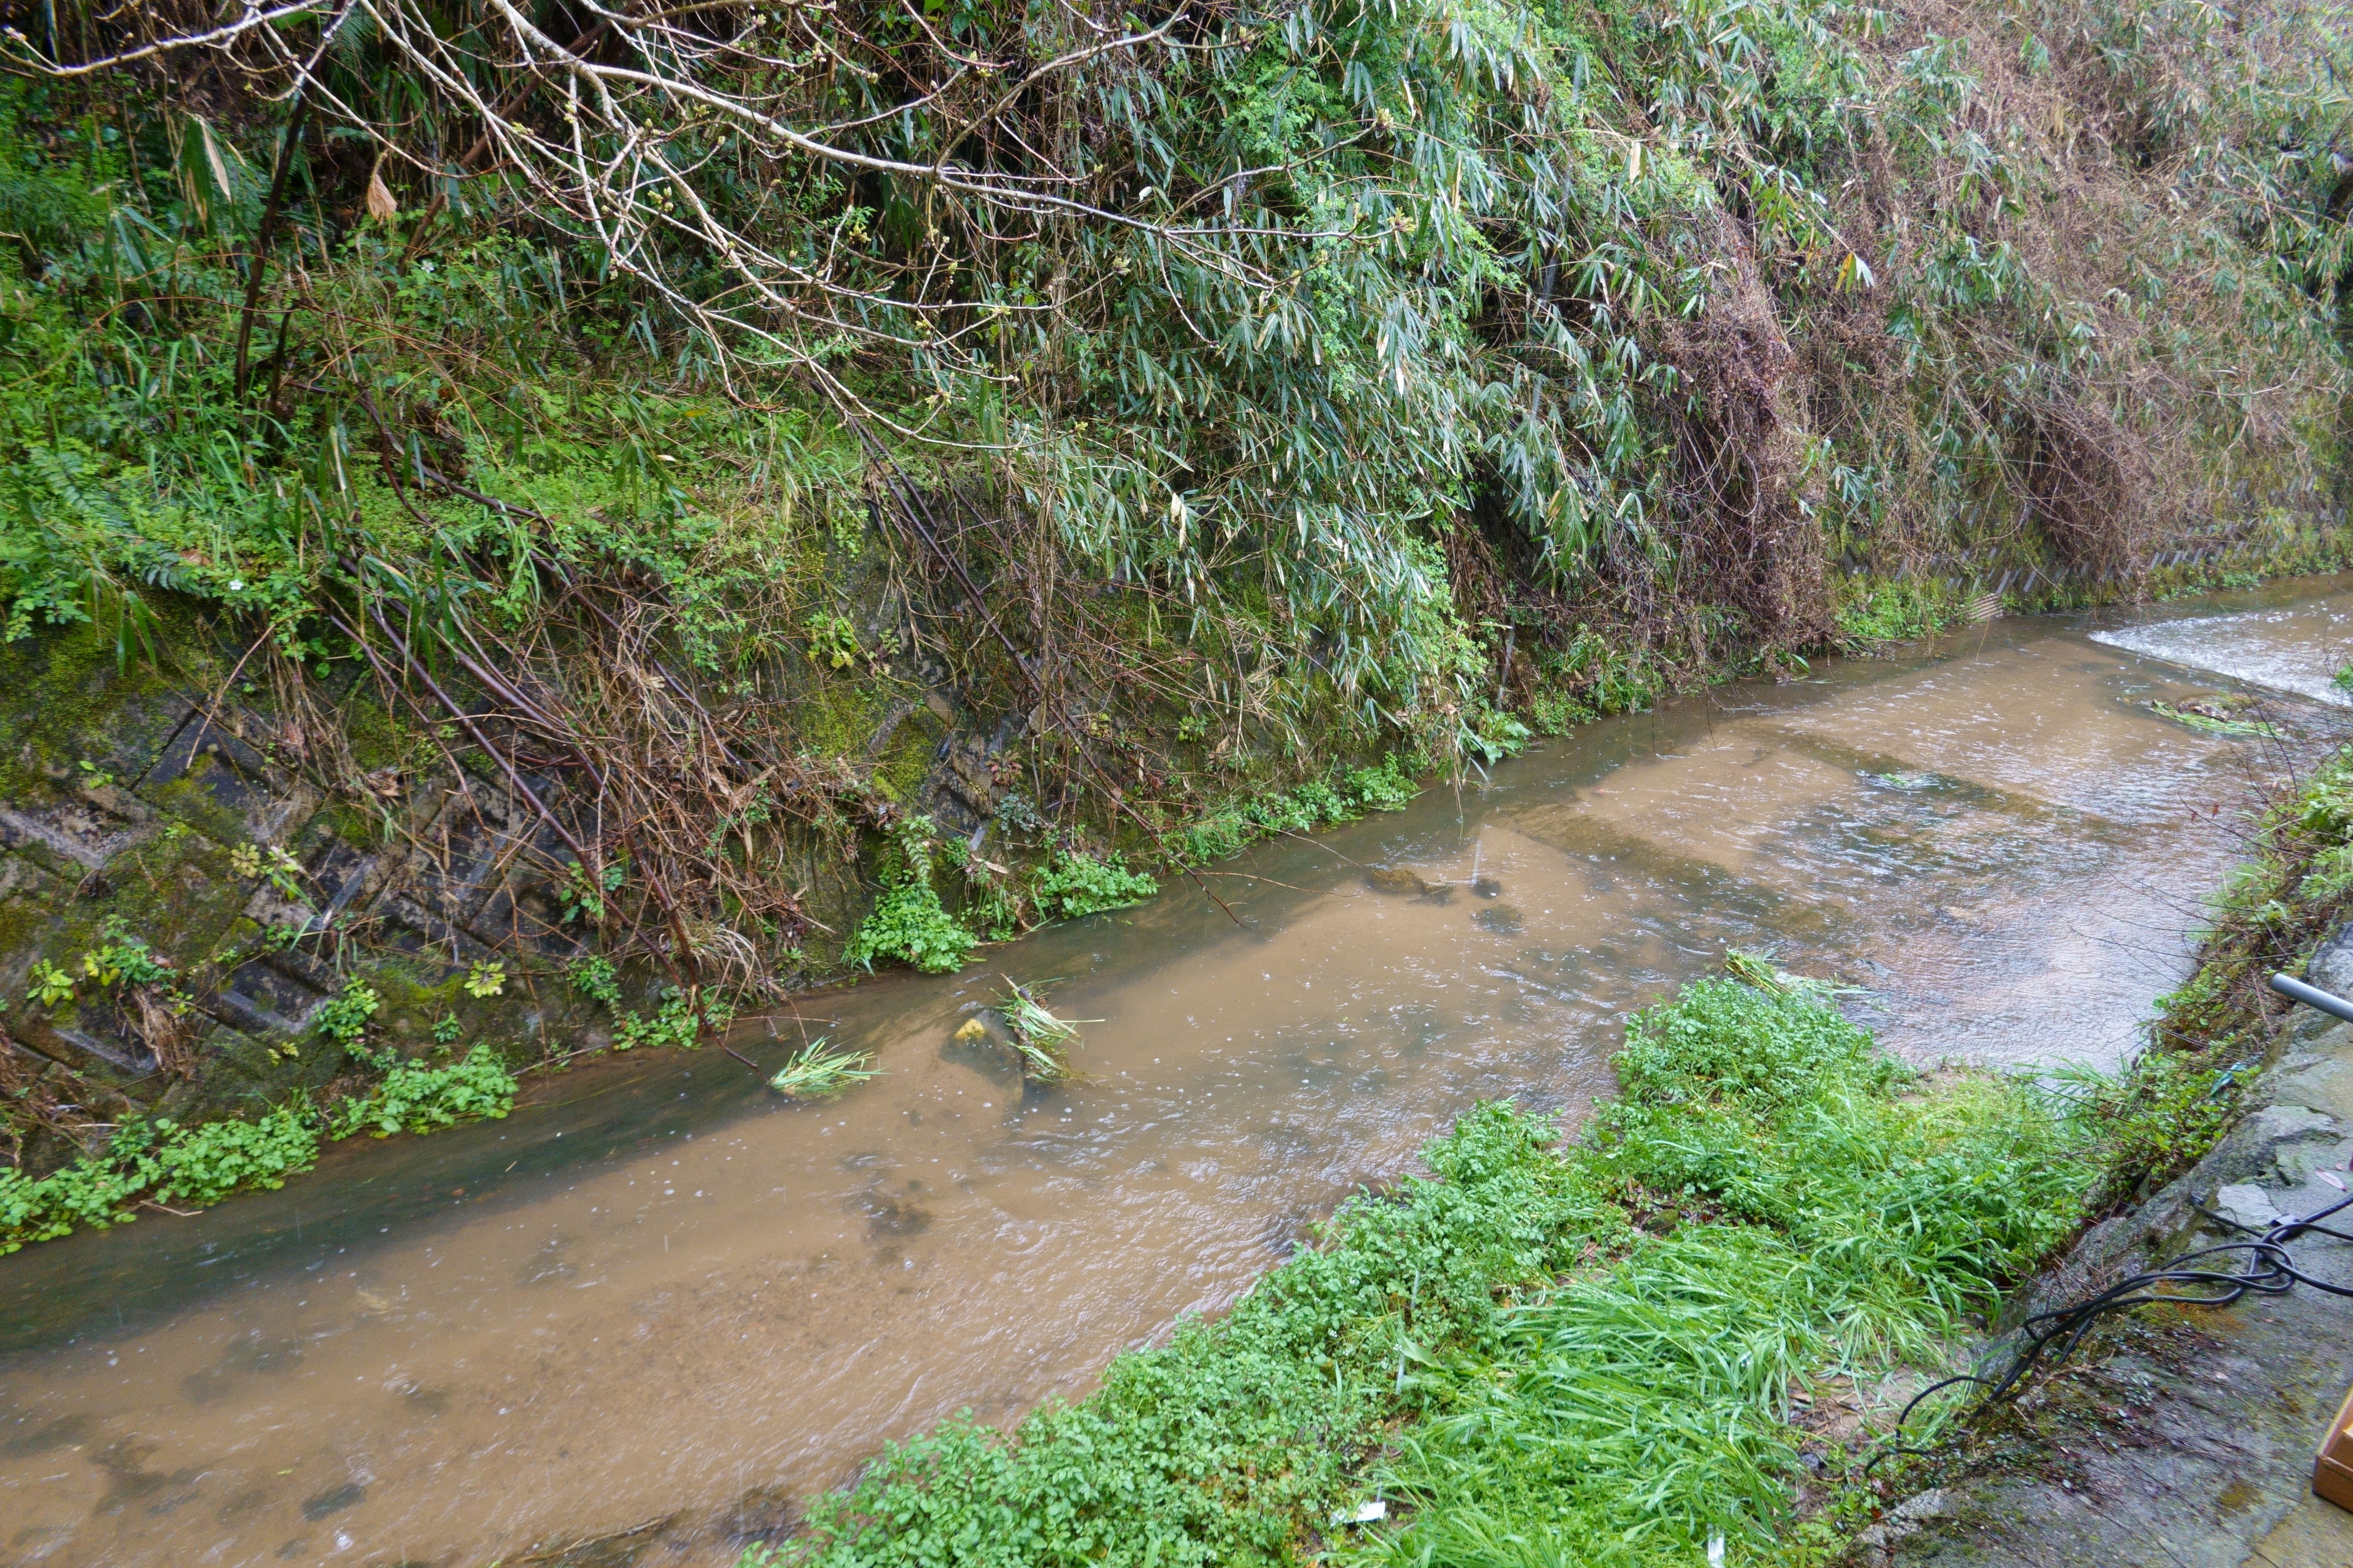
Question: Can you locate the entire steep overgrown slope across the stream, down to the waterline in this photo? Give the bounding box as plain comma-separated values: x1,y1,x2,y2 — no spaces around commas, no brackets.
0,0,2353,1203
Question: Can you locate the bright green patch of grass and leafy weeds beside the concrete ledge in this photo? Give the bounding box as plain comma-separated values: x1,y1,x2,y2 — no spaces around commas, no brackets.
746,980,2090,1568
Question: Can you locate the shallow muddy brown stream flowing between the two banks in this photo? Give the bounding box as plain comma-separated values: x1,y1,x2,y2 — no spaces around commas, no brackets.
0,578,2353,1568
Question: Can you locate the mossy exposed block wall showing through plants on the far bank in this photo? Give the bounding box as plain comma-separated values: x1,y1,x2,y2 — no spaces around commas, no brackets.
0,594,1007,1173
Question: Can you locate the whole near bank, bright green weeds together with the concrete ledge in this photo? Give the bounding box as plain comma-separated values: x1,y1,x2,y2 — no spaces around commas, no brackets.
743,747,2353,1568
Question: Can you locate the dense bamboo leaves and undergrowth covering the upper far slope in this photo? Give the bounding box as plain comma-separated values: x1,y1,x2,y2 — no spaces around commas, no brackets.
0,0,2343,738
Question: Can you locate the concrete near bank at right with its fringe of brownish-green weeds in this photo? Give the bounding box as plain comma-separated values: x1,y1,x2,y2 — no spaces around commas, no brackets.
1859,752,2353,1568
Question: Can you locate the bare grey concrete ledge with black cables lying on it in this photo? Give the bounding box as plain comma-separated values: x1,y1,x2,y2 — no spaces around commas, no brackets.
1849,933,2353,1568
